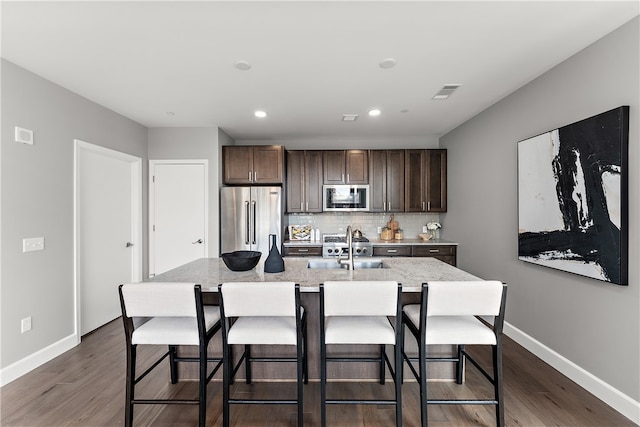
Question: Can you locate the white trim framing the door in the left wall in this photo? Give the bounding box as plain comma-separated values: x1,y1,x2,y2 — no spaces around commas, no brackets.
73,139,143,344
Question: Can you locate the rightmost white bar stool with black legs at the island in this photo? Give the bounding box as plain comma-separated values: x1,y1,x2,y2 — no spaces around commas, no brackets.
402,281,507,427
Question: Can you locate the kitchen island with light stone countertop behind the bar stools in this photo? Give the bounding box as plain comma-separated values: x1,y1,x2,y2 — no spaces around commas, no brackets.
153,257,481,381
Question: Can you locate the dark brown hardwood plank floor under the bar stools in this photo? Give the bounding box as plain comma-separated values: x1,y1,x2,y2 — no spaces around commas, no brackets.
0,319,635,427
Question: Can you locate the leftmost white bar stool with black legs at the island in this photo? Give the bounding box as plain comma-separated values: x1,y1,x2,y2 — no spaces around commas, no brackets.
118,282,222,427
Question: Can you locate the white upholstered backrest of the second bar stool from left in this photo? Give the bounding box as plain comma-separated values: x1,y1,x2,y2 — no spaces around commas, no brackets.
220,282,296,317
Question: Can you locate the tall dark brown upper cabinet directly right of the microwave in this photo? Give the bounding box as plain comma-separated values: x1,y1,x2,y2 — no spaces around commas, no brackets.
369,150,405,212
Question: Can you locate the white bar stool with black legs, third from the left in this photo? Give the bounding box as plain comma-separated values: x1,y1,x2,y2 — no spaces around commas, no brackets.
320,281,402,427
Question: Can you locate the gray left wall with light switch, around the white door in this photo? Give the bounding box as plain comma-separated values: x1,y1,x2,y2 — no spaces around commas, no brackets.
0,60,147,368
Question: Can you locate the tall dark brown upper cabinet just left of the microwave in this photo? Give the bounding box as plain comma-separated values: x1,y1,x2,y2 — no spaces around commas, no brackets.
287,150,322,213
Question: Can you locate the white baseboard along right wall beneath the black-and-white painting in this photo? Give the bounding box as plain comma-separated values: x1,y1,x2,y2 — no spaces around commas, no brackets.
504,322,640,425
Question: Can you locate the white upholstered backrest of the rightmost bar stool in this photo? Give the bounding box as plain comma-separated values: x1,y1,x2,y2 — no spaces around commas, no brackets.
427,280,503,316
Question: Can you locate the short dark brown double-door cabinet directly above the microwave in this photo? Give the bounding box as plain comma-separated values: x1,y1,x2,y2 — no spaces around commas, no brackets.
323,150,369,185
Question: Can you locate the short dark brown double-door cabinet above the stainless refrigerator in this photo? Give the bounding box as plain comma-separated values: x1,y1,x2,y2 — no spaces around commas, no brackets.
222,145,284,185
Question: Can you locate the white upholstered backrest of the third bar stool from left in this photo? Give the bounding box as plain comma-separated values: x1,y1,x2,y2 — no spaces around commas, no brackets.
323,281,398,316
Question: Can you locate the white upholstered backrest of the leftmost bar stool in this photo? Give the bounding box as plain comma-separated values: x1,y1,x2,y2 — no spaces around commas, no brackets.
122,282,196,317
